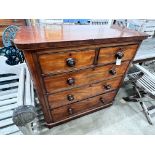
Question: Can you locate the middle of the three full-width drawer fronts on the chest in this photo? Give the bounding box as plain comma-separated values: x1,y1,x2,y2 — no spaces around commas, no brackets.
48,77,122,108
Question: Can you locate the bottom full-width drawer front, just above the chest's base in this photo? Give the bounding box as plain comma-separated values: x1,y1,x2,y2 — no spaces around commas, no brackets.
52,91,116,122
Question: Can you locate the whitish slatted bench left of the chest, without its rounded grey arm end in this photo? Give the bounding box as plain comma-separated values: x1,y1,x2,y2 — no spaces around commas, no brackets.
0,56,34,134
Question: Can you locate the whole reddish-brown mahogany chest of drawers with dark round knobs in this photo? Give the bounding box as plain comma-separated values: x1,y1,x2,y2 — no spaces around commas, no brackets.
14,25,147,127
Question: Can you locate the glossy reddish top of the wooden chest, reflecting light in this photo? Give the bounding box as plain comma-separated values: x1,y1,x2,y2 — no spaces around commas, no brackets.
14,25,147,49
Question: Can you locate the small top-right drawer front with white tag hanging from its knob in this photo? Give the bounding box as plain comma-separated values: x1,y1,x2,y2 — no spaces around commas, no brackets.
98,45,138,64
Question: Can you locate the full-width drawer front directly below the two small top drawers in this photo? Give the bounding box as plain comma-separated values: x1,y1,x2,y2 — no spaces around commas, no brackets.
44,61,129,93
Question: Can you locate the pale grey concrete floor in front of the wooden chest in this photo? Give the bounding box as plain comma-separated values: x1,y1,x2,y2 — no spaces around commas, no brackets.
42,83,155,135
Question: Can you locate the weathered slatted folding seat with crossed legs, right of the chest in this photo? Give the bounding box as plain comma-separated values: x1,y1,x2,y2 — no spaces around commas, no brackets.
123,65,155,125
